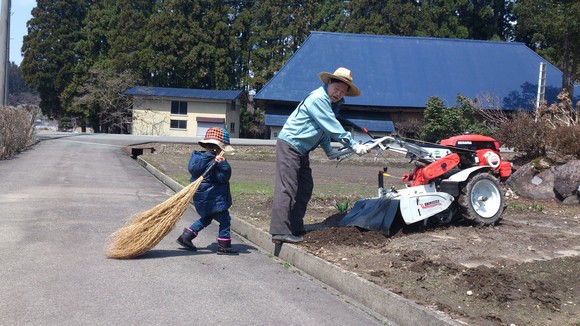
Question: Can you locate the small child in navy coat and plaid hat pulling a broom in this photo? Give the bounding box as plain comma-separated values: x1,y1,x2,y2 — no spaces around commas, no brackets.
177,128,238,255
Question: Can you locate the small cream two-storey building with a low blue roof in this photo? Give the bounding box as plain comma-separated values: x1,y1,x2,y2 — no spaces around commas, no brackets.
124,86,247,138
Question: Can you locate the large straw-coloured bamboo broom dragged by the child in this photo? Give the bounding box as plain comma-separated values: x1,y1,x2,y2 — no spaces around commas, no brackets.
106,151,224,259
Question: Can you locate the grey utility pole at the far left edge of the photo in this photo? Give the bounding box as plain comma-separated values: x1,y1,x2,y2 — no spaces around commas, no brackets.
0,0,11,106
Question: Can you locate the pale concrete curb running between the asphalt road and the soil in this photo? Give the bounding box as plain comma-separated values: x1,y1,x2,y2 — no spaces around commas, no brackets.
137,156,461,326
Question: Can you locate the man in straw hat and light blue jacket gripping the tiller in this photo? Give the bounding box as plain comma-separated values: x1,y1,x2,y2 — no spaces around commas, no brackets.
270,67,368,243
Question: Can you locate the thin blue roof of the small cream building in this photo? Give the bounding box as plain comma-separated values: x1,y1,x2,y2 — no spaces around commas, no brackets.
123,86,242,101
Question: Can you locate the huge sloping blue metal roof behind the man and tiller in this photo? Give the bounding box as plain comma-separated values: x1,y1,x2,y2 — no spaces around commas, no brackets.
255,32,580,109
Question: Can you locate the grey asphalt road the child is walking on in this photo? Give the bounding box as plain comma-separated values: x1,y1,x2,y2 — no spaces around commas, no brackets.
0,133,389,325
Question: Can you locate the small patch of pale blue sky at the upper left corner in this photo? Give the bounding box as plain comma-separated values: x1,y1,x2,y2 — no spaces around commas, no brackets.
9,0,36,66
